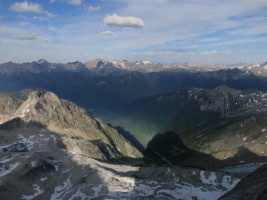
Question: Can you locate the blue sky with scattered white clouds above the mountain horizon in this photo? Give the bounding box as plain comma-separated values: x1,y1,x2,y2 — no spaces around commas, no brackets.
0,0,267,64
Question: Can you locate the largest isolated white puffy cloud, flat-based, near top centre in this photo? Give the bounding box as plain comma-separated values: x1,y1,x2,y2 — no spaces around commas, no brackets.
103,14,145,28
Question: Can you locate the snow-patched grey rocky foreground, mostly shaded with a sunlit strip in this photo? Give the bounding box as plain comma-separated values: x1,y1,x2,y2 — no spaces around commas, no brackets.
0,128,244,200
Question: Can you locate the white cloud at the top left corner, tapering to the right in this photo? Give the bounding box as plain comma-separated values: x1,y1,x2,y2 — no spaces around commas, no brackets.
9,1,53,17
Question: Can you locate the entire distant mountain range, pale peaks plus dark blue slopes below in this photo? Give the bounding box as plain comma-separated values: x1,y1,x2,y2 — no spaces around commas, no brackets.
0,59,267,115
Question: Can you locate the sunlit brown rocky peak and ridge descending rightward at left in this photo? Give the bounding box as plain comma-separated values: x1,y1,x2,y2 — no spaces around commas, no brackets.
2,90,141,159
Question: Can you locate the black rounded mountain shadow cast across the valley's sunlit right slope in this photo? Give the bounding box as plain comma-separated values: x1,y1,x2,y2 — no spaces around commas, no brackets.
144,132,267,170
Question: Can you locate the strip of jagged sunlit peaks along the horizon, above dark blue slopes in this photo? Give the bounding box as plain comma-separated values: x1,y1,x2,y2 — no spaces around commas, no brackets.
0,59,267,76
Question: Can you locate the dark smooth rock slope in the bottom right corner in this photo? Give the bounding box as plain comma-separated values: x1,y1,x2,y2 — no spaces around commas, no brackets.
220,165,267,200
